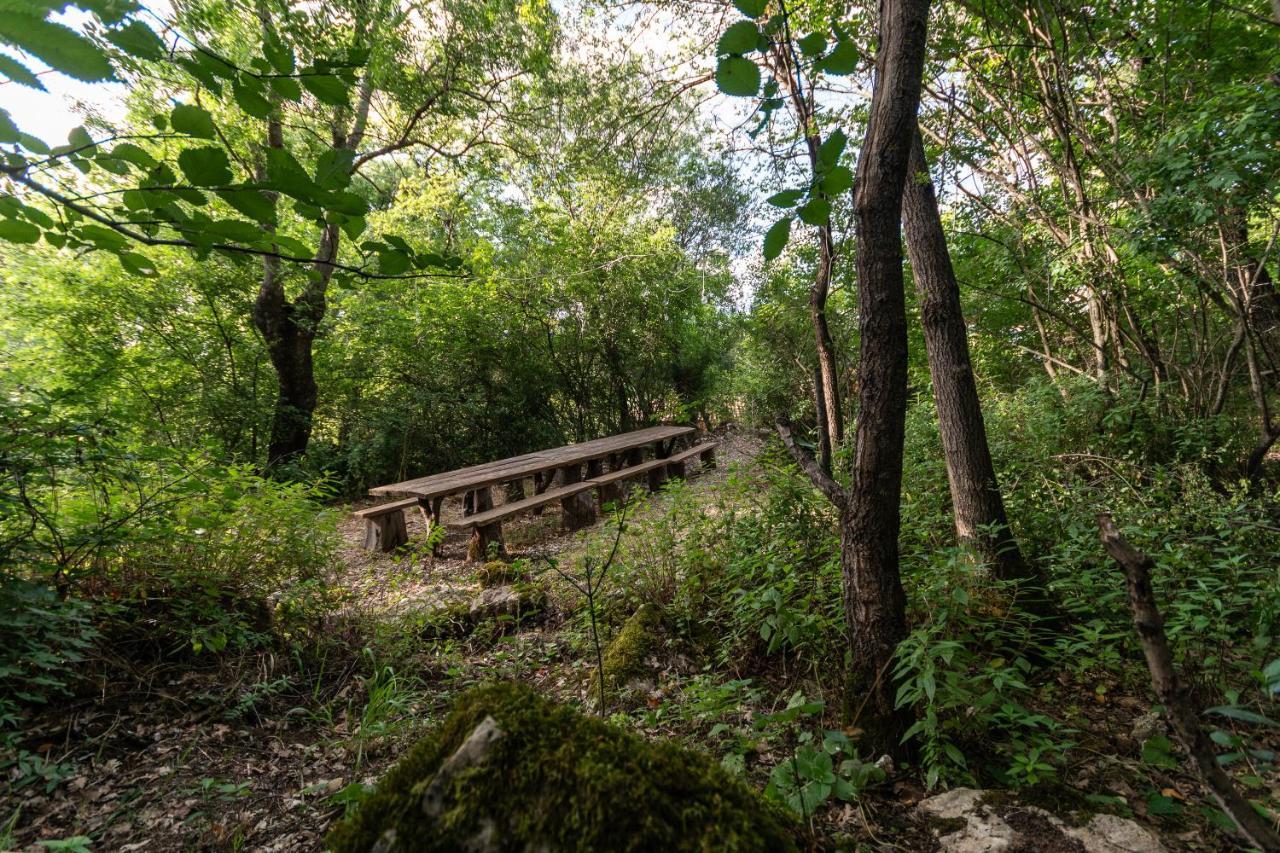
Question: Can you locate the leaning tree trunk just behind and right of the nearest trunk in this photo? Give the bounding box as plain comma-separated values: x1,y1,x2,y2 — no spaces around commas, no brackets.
902,131,1036,589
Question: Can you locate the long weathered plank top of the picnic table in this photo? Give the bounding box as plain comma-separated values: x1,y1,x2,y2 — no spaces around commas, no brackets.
369,427,696,498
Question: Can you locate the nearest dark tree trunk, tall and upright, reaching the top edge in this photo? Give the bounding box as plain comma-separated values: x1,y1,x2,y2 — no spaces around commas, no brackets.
841,0,929,752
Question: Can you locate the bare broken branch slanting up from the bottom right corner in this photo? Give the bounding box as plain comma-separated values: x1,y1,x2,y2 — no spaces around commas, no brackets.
1098,512,1280,852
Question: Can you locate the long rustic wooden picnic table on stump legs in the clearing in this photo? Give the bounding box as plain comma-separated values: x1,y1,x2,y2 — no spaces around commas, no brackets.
357,427,696,560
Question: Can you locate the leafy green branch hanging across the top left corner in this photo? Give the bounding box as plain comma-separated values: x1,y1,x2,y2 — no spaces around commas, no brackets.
0,0,462,278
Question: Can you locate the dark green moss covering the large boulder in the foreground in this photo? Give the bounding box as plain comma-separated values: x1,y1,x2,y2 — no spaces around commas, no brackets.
328,684,797,853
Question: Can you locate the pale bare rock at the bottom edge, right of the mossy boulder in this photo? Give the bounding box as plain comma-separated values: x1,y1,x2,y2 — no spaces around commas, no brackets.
916,788,1162,853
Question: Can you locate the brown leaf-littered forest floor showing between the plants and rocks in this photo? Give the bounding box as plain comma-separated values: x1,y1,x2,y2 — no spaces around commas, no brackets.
0,435,1254,850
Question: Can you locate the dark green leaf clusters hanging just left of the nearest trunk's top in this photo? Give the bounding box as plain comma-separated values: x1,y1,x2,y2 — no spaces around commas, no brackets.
716,0,859,260
